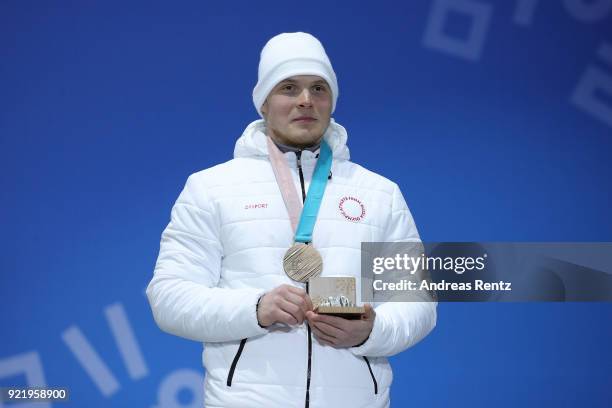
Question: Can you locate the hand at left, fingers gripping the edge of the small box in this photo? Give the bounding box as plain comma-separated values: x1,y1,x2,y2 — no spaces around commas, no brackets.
257,284,312,327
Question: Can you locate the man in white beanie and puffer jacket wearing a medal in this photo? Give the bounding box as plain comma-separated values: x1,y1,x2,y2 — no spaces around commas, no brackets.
147,33,436,408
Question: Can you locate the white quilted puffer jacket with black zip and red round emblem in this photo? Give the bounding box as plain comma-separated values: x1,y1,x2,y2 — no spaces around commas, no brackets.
147,119,436,408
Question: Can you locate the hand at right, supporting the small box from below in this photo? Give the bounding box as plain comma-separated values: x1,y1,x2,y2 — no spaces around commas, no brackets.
306,303,376,348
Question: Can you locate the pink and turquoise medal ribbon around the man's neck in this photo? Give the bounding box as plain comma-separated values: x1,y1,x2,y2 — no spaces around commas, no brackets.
267,137,332,244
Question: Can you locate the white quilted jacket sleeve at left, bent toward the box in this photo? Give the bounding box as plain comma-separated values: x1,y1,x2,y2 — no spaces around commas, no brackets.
147,175,267,342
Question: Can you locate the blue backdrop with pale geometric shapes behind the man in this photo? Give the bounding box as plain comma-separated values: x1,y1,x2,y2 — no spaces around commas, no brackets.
0,0,612,408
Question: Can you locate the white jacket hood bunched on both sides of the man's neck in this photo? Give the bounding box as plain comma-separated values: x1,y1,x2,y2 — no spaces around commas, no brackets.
234,118,350,160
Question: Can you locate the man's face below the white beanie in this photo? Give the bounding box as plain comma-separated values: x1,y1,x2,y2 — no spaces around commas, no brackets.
261,75,332,148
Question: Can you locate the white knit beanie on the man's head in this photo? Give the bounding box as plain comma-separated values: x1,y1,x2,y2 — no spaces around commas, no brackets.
253,32,338,118
